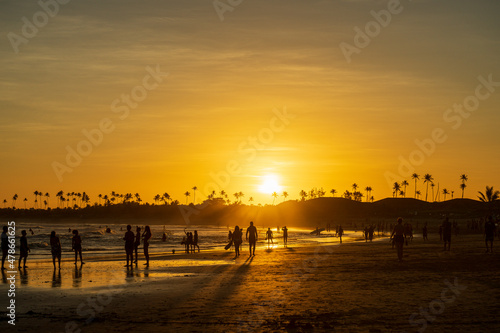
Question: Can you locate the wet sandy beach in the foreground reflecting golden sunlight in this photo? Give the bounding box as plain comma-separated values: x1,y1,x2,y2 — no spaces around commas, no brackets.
0,234,500,332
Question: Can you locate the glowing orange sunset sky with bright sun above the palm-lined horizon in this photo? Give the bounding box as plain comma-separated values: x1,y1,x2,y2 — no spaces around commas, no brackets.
0,0,500,207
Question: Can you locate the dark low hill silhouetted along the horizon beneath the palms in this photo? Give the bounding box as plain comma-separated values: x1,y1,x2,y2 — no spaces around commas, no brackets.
0,198,500,227
